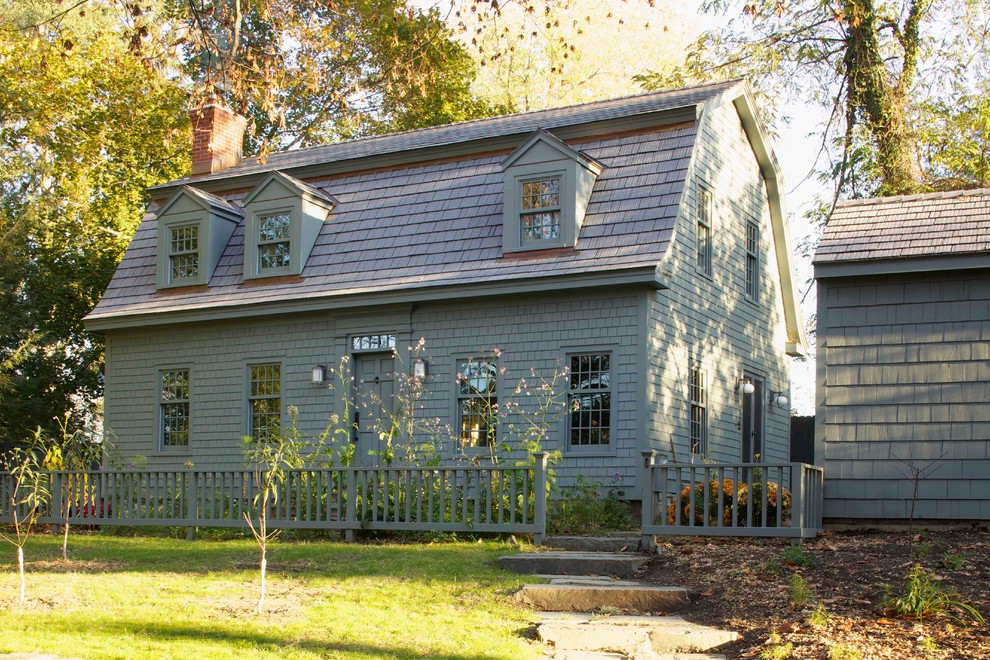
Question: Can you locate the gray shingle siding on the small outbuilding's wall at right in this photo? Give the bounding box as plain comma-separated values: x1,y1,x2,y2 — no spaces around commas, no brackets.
818,270,990,519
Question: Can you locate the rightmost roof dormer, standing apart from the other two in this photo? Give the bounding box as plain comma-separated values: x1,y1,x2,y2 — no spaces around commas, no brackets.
502,131,603,253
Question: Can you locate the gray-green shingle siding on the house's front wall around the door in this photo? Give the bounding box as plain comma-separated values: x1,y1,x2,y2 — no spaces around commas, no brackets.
106,289,643,487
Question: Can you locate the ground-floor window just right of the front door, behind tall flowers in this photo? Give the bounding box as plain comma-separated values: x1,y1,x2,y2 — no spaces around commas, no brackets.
457,358,498,448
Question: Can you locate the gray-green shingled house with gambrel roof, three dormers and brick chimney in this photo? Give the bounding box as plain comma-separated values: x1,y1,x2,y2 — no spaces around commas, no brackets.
86,81,805,494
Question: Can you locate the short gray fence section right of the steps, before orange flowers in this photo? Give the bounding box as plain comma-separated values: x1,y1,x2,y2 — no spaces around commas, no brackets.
641,452,824,540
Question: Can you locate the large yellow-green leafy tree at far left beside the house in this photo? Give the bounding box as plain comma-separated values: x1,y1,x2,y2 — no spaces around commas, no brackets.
0,0,188,444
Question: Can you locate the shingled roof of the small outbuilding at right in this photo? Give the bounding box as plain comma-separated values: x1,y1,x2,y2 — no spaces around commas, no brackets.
814,189,990,276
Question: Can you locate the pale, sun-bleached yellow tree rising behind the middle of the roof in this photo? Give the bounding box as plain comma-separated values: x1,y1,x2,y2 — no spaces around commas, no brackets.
460,0,700,110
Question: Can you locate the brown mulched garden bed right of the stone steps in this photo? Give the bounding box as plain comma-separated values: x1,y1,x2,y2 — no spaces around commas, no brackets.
640,529,990,660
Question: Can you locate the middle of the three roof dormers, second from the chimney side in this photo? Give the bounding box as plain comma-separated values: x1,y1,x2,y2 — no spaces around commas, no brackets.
244,172,336,280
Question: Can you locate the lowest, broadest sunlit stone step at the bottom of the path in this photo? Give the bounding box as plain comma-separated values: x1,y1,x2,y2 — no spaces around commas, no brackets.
537,613,738,659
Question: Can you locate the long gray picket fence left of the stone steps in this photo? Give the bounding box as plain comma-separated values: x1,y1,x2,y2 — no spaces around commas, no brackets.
0,453,547,544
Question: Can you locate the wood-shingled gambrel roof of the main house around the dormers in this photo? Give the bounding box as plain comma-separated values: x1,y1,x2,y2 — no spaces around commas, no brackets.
81,81,801,350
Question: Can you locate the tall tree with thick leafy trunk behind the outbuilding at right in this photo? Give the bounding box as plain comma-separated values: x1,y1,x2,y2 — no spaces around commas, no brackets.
641,0,988,195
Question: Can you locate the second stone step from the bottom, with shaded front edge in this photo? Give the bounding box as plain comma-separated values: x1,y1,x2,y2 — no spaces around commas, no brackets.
513,584,690,612
